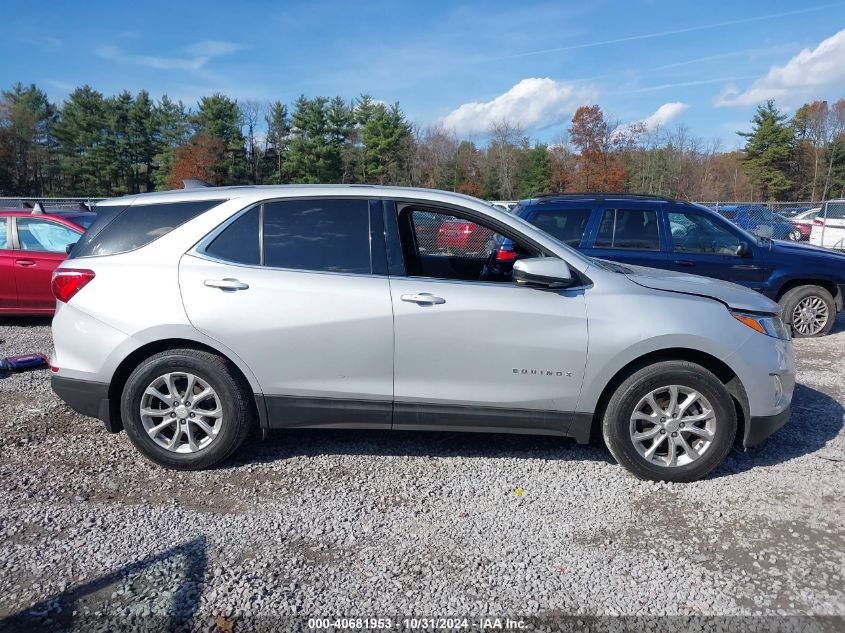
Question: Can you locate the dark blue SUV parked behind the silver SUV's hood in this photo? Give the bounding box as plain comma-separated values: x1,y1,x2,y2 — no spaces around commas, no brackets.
500,193,845,337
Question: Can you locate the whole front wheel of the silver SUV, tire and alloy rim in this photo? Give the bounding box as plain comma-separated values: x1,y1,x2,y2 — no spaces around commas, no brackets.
602,361,737,482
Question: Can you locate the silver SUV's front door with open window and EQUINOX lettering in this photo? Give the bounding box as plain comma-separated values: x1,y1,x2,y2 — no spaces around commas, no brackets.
386,204,587,434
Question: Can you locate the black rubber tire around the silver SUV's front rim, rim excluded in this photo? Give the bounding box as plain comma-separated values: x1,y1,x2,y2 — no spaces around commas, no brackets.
602,361,737,482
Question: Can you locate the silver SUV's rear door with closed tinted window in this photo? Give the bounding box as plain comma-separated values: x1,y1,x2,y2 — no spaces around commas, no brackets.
179,199,393,428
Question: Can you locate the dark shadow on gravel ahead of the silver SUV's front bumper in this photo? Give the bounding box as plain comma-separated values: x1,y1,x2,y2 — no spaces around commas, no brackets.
711,383,845,477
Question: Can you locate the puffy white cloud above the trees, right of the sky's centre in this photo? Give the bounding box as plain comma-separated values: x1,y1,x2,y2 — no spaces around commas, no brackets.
441,77,598,136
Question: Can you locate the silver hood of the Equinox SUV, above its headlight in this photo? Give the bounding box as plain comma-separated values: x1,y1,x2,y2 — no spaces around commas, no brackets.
625,265,780,314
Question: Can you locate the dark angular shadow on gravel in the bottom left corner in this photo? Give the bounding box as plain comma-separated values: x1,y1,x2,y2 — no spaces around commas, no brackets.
0,536,208,631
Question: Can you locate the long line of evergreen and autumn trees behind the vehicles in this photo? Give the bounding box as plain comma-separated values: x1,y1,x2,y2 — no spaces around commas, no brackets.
0,83,845,201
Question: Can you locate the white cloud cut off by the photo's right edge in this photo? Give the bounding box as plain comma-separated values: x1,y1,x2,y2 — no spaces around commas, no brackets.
715,29,845,107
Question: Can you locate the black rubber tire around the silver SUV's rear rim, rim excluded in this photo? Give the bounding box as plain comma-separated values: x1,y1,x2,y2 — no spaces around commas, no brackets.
120,349,256,470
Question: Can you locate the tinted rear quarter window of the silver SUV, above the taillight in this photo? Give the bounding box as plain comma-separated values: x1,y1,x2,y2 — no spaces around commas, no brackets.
70,200,223,257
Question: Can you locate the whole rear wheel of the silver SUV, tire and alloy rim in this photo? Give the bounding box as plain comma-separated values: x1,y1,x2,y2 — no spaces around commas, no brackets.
121,349,253,470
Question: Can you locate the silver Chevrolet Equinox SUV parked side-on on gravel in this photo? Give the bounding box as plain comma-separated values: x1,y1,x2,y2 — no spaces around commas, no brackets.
52,185,795,481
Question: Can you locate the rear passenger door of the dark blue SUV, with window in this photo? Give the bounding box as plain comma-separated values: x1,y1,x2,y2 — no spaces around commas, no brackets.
582,201,669,268
